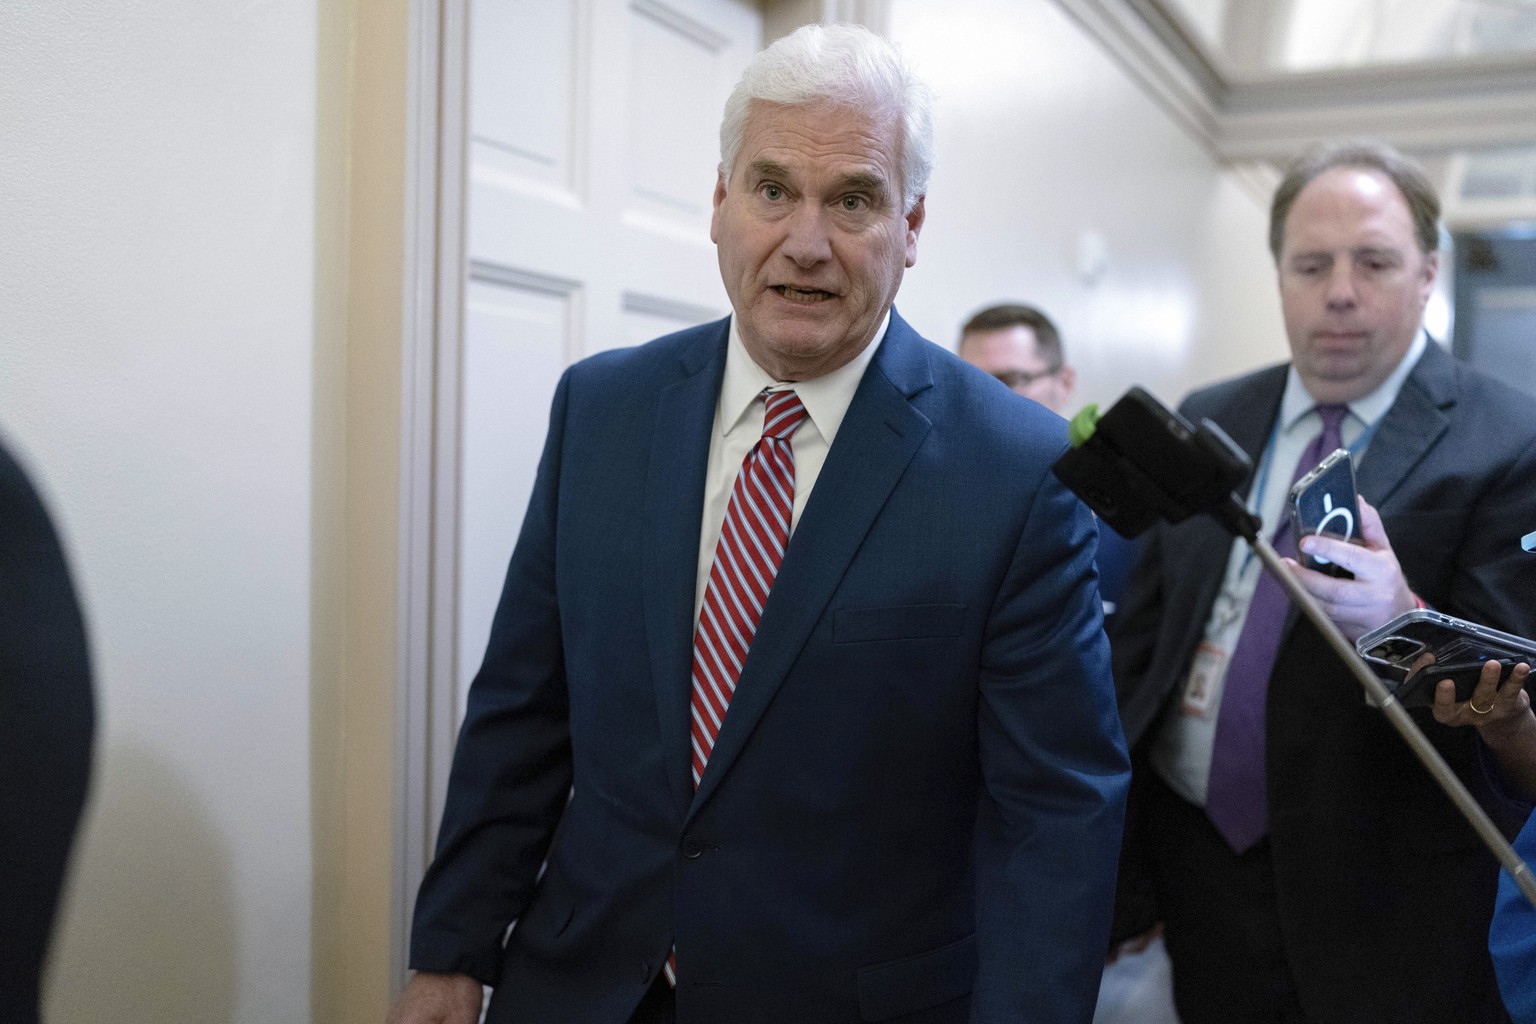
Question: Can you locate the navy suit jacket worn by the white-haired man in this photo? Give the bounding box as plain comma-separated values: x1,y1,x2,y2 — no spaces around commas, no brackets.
412,312,1127,1024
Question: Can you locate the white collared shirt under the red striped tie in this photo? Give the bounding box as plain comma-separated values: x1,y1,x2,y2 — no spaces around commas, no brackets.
693,310,891,623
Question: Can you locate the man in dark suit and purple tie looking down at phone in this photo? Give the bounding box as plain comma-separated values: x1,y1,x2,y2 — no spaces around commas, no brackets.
1114,143,1536,1024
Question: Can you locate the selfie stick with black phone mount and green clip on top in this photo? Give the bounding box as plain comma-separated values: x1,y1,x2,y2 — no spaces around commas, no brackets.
1054,387,1536,907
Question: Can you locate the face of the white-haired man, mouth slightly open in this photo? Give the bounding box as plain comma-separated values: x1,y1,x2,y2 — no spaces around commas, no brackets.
710,103,923,381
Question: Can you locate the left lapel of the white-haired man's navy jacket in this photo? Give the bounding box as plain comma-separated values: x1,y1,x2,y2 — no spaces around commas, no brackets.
645,321,728,814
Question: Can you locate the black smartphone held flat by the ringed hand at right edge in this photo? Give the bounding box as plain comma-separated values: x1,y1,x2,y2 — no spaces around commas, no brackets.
1355,608,1536,708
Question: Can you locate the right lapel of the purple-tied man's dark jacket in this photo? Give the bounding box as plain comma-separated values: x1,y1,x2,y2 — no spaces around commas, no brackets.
1355,341,1456,508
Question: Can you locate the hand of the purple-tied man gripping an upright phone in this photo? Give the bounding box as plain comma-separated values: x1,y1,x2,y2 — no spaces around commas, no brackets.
1286,499,1418,640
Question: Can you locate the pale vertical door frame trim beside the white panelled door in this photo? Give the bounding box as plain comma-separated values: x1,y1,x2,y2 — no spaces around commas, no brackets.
390,0,468,990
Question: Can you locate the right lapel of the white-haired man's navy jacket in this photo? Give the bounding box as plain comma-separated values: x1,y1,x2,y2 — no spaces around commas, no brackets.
690,310,932,817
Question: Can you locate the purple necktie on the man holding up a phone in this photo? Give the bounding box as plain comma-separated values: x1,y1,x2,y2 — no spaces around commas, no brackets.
1206,405,1349,854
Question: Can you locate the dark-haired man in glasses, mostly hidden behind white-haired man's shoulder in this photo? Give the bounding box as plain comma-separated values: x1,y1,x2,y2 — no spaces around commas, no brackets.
960,304,1135,623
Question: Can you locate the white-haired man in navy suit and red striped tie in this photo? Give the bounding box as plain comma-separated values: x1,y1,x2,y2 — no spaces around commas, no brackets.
392,26,1127,1024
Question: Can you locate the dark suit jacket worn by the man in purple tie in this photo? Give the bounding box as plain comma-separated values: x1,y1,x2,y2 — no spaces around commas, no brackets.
1115,344,1536,1024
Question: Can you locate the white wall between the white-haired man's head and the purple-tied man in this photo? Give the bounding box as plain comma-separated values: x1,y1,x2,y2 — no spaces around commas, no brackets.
891,0,1287,404
